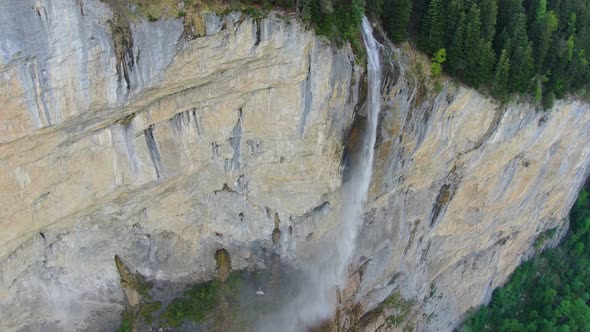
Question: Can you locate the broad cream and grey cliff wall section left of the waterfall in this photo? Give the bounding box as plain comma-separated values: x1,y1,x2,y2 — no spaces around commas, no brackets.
0,0,360,331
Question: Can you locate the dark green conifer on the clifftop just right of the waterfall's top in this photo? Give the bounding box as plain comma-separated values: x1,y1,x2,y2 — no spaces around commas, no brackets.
383,0,412,43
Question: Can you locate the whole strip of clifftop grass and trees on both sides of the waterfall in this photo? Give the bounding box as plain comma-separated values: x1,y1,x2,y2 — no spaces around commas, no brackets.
120,0,590,104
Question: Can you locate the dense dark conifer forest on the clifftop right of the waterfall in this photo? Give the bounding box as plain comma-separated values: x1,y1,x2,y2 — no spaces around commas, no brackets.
374,0,590,108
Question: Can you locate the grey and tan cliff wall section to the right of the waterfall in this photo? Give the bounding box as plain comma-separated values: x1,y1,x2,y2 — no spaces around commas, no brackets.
342,46,590,331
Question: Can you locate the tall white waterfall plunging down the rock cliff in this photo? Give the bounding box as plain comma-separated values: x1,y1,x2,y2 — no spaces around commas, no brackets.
258,17,381,331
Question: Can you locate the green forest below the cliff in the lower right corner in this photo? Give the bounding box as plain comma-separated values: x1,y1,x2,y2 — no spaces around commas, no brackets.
461,185,590,332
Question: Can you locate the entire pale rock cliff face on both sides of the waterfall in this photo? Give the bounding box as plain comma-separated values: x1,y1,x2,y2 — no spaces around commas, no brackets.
0,0,590,331
